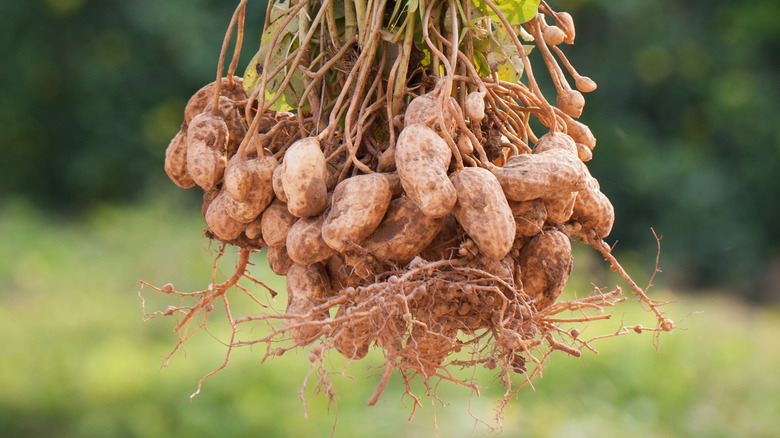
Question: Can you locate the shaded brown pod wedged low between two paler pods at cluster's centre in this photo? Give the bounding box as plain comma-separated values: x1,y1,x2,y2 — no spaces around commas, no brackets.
363,197,444,265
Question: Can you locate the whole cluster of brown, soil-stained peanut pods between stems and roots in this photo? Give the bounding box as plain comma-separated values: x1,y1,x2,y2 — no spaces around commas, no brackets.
165,72,614,359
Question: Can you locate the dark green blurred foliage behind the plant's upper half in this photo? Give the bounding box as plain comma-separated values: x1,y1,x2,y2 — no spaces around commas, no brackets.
0,0,780,299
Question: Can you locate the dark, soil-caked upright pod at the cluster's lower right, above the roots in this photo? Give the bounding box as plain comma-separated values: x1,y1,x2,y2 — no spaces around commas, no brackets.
517,230,574,310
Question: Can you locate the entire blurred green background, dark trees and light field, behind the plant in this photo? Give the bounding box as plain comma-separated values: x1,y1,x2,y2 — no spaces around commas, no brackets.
0,0,780,437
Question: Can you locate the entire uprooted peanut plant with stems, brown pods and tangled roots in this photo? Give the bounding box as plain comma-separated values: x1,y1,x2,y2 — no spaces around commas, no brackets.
146,0,673,424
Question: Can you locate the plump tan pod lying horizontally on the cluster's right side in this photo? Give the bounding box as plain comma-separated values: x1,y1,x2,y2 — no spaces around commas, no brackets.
493,149,587,201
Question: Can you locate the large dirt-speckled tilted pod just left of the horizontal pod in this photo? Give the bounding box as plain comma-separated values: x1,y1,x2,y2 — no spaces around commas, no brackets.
450,167,516,260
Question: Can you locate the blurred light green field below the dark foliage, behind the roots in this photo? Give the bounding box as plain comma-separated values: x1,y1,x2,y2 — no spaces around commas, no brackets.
0,197,780,437
